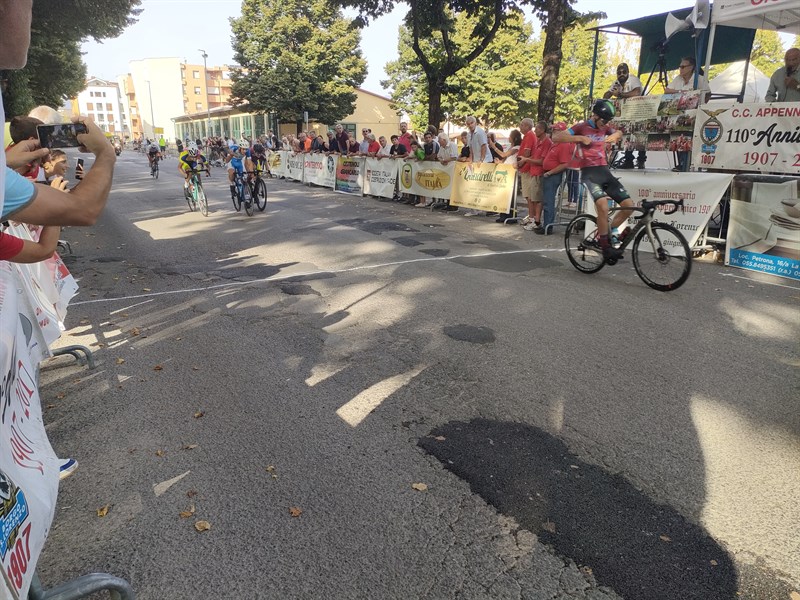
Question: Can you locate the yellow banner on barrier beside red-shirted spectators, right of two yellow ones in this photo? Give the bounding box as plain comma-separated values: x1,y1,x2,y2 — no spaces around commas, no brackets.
450,162,517,213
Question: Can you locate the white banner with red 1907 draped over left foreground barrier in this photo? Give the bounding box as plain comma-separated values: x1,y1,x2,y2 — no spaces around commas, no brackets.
0,261,58,599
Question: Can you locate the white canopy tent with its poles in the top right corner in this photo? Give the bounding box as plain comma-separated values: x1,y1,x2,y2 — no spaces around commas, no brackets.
705,0,800,95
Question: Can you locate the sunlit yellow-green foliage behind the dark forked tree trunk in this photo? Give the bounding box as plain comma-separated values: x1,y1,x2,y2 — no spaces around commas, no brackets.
381,14,541,129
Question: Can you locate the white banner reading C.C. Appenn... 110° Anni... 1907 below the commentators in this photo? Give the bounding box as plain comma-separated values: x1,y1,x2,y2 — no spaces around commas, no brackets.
692,102,800,175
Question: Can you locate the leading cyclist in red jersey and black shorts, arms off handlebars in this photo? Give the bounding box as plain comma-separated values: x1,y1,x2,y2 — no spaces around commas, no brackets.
553,100,635,258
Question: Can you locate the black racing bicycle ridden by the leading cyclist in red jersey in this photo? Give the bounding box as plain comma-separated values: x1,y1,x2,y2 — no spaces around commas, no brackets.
564,198,692,292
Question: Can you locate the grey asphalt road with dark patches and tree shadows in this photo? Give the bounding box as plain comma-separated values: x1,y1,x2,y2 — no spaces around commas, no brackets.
39,152,800,600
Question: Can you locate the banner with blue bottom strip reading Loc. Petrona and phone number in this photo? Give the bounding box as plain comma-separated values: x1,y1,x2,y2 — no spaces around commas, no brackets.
725,175,800,281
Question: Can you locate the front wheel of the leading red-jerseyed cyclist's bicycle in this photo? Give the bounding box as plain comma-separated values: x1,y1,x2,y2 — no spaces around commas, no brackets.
631,223,692,292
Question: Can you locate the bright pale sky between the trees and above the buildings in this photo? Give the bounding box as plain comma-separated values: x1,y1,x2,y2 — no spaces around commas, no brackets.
83,0,792,95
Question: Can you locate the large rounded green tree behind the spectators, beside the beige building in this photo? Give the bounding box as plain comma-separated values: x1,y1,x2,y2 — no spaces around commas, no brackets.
231,0,367,123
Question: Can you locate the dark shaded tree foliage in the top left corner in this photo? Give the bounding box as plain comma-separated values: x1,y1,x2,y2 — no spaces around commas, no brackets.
3,0,141,118
